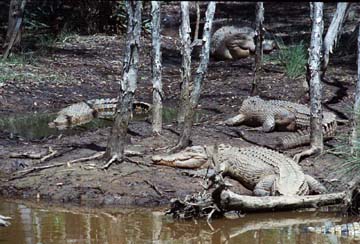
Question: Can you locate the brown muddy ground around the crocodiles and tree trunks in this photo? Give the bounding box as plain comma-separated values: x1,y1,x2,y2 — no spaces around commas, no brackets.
0,2,356,206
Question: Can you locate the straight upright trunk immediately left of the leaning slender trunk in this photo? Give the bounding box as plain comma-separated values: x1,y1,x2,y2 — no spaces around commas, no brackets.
177,1,192,123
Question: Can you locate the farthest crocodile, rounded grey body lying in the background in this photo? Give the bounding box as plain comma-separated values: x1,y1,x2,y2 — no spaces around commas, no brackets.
211,26,276,60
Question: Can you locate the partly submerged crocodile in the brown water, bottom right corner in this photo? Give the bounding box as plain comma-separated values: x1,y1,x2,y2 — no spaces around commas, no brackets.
305,222,360,238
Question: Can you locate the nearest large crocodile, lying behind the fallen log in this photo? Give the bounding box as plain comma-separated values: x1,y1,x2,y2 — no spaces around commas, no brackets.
152,144,326,196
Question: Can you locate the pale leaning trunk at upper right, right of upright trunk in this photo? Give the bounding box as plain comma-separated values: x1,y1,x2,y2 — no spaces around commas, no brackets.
321,2,349,76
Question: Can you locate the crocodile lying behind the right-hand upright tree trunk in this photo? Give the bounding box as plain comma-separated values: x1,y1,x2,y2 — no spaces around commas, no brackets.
225,96,337,149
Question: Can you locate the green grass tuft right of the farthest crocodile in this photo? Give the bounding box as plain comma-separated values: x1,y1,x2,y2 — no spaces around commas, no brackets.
264,38,307,79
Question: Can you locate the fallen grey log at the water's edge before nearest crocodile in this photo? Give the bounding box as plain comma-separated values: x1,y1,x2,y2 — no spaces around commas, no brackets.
218,190,348,212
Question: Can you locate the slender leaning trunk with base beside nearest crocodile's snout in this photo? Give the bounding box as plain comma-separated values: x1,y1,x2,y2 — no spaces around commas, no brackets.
171,1,216,152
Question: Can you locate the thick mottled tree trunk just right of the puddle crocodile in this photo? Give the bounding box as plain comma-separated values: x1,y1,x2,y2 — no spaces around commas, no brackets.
105,1,142,161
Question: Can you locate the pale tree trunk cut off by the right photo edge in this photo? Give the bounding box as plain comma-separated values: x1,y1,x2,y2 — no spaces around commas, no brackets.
350,24,360,156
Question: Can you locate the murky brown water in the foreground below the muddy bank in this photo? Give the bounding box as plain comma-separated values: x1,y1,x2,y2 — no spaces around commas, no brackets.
0,200,360,244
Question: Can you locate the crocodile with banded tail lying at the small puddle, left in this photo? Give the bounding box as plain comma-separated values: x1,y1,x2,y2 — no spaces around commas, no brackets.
48,98,151,129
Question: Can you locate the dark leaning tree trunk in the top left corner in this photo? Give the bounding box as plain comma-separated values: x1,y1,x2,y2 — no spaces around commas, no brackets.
3,0,26,59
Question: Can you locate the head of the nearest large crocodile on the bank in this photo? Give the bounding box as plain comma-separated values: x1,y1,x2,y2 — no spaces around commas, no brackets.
151,146,208,169
